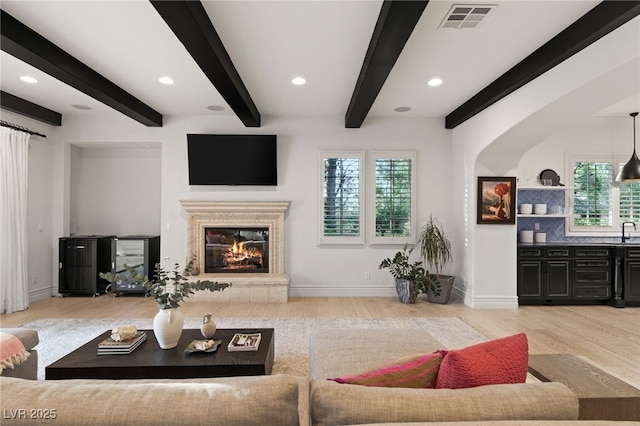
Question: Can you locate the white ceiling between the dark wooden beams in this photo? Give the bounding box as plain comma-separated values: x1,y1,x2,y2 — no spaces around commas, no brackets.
0,0,640,123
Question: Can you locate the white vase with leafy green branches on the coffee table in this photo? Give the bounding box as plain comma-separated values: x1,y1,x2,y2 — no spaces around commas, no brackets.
100,258,231,349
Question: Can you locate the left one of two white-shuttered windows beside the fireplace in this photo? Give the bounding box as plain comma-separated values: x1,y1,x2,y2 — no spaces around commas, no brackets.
320,152,364,244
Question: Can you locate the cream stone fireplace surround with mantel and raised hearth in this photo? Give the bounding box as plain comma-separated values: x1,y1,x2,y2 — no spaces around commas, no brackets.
180,200,290,303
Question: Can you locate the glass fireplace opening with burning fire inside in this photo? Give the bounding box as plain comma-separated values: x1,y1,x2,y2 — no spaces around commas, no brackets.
204,228,269,273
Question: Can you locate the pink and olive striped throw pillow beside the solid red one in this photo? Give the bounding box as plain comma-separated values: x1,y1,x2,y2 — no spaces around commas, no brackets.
329,353,442,388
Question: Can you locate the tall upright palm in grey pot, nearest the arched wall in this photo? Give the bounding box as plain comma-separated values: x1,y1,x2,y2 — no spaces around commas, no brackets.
418,215,455,304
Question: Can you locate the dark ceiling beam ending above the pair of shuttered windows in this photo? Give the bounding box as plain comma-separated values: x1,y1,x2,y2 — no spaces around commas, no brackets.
344,0,429,128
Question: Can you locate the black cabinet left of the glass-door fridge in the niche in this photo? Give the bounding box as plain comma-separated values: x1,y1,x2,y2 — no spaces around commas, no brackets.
58,235,114,296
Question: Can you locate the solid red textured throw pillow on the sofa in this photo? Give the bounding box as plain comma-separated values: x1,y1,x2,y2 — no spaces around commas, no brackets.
436,333,529,389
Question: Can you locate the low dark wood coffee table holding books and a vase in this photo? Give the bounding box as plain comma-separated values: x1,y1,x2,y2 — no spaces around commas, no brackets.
45,328,274,380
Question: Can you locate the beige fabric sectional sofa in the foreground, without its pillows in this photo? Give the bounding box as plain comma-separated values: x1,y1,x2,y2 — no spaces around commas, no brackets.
0,330,632,426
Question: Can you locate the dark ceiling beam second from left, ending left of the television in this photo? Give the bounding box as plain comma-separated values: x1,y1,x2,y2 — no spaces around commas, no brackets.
0,10,162,127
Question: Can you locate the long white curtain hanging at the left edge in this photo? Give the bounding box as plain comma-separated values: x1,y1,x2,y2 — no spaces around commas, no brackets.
0,127,30,314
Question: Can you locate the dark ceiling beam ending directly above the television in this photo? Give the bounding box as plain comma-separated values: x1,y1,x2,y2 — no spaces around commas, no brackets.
150,0,260,127
